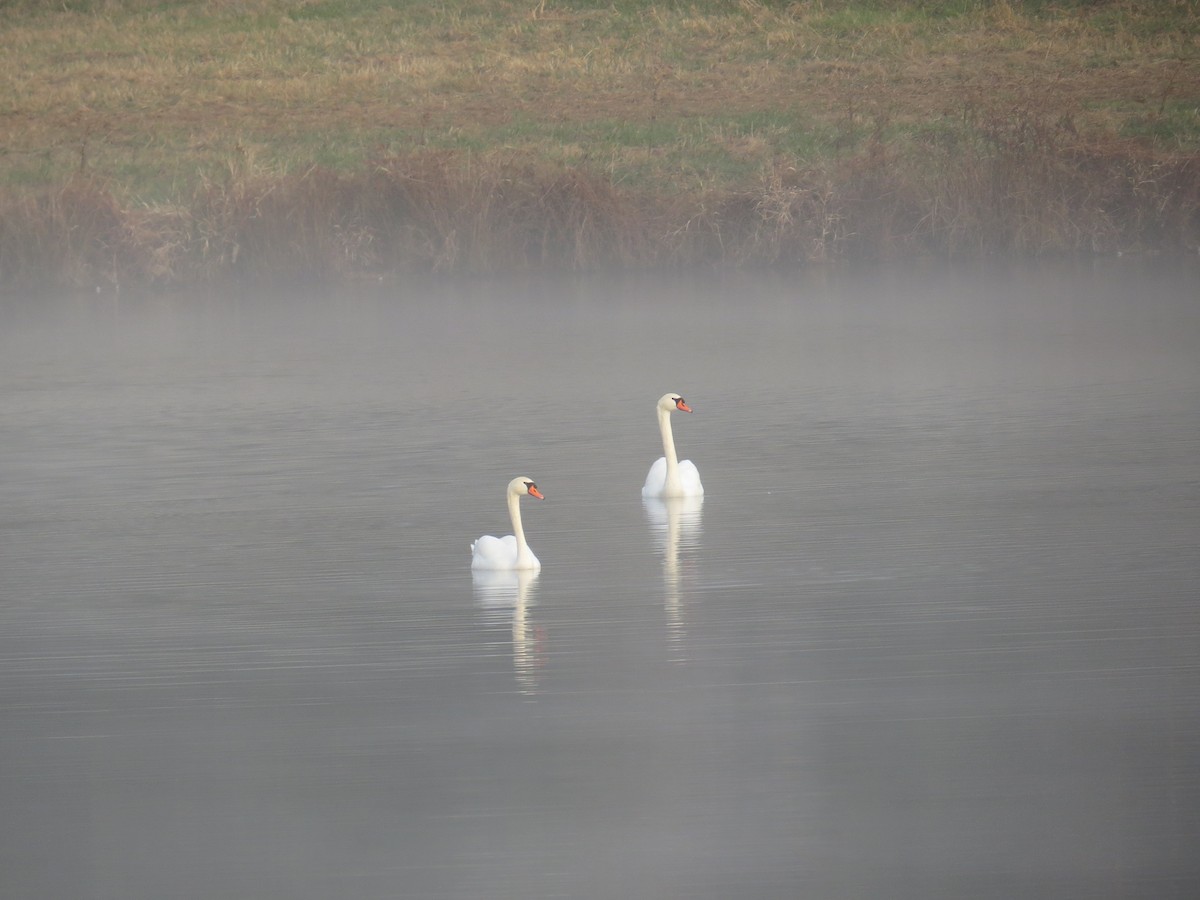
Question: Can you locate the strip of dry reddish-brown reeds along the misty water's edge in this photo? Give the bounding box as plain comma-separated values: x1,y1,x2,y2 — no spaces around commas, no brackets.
0,131,1200,286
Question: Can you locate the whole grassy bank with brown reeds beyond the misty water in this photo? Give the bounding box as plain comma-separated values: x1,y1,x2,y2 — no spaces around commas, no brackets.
0,0,1200,286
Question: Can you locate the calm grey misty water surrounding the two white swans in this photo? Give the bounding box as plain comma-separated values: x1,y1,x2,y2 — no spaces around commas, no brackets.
0,263,1200,900
